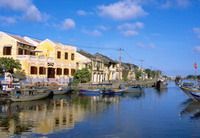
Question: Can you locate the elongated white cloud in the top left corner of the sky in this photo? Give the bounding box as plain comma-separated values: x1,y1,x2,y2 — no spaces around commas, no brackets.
0,0,43,21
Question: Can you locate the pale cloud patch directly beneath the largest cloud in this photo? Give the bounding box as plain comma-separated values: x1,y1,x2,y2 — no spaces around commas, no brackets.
117,22,144,36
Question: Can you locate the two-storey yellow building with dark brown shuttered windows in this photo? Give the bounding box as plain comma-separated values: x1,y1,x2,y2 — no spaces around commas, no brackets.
0,32,76,84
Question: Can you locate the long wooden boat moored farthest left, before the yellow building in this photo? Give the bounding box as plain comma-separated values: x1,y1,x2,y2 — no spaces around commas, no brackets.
10,89,51,102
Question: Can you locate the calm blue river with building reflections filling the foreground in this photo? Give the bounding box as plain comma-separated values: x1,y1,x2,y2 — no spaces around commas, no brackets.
0,83,200,138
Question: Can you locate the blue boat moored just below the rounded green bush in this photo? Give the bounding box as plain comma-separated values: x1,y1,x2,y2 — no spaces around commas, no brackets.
79,89,102,96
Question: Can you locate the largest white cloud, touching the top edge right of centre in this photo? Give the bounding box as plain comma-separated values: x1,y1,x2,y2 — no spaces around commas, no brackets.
98,0,147,20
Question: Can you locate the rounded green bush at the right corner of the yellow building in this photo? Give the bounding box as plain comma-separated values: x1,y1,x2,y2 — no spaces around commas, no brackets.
74,68,91,83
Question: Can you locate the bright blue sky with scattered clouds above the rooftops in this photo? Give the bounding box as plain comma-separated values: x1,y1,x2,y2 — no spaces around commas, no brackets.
0,0,200,75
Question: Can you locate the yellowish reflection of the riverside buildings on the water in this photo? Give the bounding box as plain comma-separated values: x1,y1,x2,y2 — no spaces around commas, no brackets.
0,95,120,137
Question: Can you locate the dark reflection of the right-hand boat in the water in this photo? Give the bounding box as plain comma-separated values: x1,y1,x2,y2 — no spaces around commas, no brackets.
180,99,200,119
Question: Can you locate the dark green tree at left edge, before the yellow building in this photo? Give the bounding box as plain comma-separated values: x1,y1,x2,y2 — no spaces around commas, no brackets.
0,57,21,74
